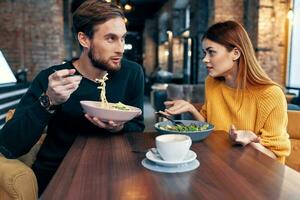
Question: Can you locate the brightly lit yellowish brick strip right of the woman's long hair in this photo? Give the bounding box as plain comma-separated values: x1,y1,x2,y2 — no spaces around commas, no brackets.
257,0,288,85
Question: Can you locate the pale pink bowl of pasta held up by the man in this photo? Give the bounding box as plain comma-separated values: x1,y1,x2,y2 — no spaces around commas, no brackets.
80,101,142,122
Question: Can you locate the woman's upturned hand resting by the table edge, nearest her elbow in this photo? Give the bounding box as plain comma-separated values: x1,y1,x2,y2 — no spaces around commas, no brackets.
229,125,260,146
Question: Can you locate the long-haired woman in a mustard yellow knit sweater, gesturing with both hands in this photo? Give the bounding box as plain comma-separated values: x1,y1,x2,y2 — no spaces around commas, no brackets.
165,21,290,163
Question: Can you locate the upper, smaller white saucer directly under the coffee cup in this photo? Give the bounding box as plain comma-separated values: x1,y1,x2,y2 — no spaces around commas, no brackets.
146,150,197,167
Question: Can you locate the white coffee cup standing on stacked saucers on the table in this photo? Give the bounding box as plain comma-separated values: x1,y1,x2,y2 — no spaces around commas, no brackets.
155,134,192,162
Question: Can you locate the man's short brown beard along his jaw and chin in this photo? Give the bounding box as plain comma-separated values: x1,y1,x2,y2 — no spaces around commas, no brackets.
88,46,121,71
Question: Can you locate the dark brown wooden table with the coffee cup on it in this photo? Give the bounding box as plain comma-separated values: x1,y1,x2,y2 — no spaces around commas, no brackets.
42,131,300,200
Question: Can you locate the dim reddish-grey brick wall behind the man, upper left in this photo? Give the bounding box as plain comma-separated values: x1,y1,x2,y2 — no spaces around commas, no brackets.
0,0,65,80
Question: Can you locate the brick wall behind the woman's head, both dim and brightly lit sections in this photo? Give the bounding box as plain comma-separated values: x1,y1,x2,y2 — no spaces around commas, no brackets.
210,0,289,85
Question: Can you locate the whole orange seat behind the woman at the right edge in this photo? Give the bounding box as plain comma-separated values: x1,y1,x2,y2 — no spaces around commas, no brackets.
286,110,300,172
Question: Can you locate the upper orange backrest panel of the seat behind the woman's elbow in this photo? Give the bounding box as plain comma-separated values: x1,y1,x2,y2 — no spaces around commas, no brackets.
287,110,300,139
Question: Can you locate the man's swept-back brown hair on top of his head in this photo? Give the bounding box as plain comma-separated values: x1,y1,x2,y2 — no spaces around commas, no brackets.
73,0,125,38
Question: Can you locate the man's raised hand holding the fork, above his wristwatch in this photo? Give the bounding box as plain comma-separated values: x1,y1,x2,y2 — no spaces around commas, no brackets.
46,69,82,105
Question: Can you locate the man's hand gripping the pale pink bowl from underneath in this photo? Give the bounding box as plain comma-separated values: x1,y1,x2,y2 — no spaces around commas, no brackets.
84,114,124,133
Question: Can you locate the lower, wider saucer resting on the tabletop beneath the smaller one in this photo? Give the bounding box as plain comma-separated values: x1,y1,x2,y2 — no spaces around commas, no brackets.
142,158,200,173
